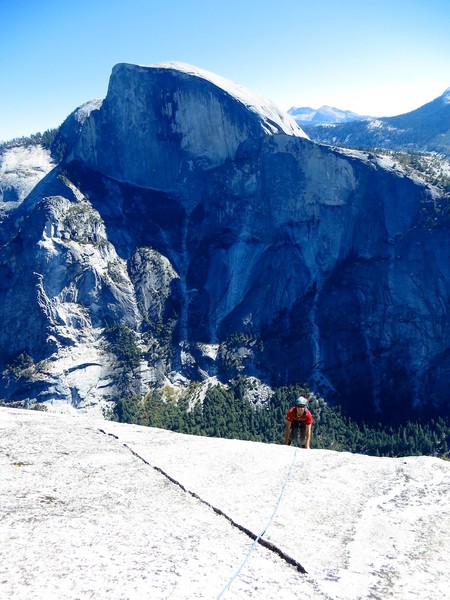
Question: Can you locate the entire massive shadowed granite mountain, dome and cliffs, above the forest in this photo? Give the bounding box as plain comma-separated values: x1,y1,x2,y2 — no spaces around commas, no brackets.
0,64,450,415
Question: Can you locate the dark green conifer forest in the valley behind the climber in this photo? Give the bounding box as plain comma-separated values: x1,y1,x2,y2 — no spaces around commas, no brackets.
111,378,450,458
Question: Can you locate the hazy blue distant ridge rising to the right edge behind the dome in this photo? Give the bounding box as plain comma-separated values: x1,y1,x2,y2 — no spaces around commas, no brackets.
300,88,450,156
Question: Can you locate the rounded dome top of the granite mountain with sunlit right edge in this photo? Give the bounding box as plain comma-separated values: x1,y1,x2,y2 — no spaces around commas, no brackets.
59,63,307,188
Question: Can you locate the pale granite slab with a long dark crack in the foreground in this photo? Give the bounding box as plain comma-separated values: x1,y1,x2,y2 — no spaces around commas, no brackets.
0,408,450,600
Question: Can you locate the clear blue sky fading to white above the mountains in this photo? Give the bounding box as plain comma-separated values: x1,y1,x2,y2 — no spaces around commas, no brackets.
0,0,450,140
